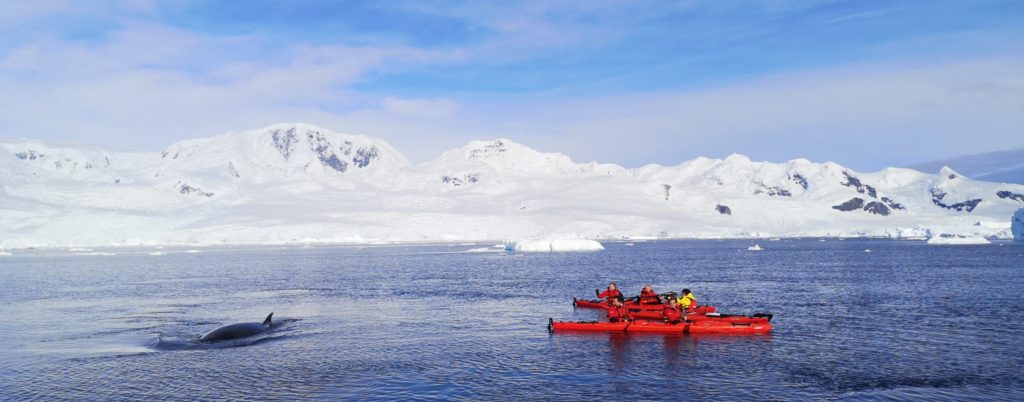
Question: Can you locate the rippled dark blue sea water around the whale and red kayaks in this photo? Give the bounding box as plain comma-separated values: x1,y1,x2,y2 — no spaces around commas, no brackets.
0,240,1024,401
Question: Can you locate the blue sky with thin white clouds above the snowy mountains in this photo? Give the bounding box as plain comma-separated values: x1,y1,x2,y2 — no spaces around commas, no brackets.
0,0,1024,171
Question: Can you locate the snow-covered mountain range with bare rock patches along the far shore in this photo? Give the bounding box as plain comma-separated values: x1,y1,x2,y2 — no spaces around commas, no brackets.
0,124,1024,249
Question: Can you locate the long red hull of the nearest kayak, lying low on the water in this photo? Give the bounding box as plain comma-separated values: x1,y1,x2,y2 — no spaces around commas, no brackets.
548,319,771,334
